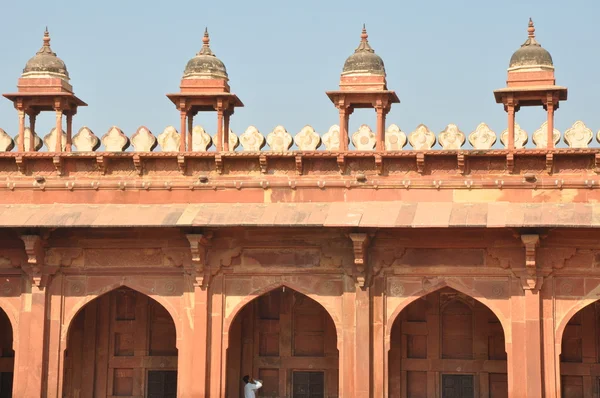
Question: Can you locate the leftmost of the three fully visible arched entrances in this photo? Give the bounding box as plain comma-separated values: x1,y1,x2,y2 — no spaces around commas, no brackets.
63,287,177,398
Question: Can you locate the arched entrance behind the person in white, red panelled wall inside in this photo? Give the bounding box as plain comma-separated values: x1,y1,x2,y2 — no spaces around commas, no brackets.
226,287,339,398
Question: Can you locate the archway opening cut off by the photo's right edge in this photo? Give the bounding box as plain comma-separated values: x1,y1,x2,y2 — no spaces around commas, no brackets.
560,301,600,398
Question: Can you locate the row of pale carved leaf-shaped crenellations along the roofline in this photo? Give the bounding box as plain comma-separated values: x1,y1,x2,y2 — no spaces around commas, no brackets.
0,121,600,152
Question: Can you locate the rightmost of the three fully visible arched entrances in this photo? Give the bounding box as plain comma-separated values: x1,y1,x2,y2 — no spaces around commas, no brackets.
388,287,508,398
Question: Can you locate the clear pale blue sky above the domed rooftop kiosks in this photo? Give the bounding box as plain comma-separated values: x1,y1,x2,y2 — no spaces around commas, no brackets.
0,0,600,149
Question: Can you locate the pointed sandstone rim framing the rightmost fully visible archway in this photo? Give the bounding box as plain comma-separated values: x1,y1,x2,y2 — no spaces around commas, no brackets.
385,278,512,351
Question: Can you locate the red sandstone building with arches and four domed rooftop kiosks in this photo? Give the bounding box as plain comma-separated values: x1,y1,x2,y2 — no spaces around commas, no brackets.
0,24,600,398
